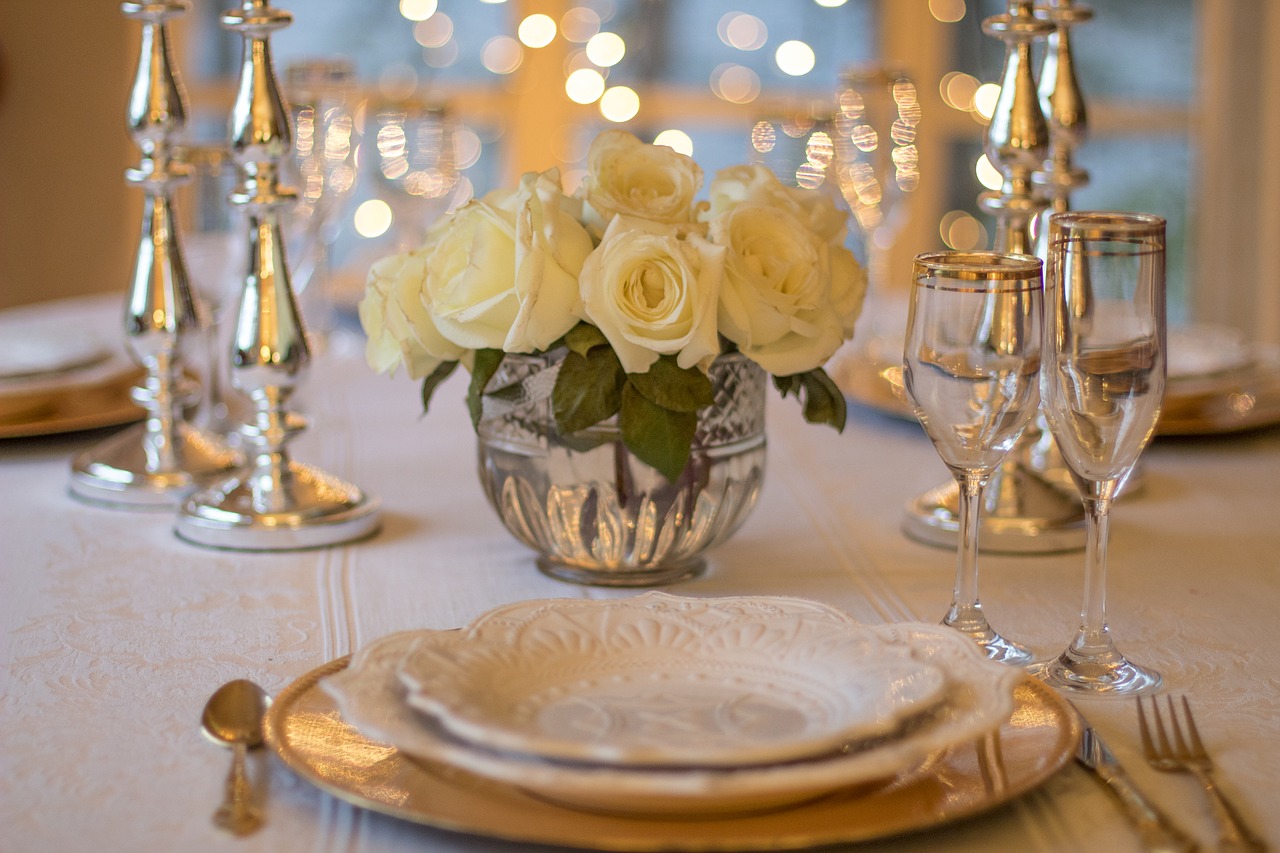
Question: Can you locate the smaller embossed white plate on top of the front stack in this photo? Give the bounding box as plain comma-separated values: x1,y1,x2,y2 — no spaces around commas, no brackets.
398,593,946,767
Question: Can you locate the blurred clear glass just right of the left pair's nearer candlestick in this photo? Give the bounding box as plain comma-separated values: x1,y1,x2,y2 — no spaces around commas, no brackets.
285,56,365,332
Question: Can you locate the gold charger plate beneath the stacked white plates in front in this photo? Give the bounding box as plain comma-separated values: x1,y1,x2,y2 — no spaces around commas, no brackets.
266,657,1079,850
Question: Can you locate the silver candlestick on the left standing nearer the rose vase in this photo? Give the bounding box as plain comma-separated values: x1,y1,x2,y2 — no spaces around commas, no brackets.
175,0,380,551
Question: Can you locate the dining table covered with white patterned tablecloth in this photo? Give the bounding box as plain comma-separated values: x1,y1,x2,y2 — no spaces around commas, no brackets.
0,294,1280,853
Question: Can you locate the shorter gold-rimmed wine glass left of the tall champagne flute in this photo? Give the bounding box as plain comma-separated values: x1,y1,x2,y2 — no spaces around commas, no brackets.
902,252,1044,665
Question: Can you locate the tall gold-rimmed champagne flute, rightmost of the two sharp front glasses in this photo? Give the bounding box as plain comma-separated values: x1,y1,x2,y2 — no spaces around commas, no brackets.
1030,213,1165,694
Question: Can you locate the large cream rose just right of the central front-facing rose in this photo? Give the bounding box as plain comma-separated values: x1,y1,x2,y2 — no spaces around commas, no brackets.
710,202,846,377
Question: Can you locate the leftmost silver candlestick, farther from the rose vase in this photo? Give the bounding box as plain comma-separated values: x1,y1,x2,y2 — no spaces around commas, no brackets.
70,0,241,508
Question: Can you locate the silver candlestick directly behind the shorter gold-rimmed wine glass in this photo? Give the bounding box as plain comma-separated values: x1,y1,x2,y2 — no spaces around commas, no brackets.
904,0,1084,553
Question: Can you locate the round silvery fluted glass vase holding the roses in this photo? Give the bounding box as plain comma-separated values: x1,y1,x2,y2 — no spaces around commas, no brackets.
476,351,765,587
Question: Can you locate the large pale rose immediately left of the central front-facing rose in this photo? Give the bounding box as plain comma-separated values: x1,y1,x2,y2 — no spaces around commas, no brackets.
424,169,593,352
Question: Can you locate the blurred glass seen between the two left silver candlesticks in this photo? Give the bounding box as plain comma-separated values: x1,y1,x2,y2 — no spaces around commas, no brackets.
175,143,246,441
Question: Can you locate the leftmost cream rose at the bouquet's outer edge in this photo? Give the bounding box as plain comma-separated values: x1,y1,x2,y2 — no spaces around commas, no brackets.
358,242,463,379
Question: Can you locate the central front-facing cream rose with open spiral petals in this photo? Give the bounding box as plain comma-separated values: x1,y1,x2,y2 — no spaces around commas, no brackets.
579,216,724,373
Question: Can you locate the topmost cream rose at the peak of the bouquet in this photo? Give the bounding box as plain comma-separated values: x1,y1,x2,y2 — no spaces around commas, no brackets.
582,131,703,224
